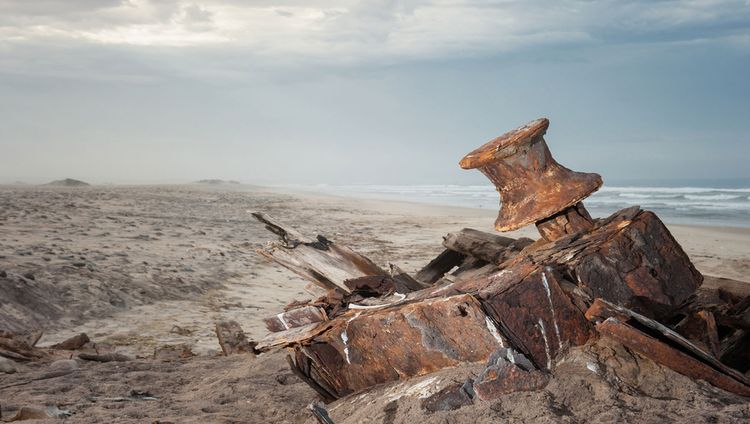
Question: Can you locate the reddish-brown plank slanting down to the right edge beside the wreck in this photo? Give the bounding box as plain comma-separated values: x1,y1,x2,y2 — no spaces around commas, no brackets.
596,317,750,396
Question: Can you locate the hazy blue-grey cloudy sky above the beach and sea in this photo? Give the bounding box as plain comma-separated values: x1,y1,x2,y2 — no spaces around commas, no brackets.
0,0,750,184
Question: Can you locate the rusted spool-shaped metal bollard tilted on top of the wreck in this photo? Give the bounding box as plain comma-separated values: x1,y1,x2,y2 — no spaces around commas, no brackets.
459,118,602,231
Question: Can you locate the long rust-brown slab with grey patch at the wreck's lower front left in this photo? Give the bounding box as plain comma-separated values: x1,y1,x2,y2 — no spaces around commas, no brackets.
301,295,505,397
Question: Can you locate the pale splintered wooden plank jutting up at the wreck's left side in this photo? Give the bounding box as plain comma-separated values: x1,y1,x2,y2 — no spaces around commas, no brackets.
253,212,388,293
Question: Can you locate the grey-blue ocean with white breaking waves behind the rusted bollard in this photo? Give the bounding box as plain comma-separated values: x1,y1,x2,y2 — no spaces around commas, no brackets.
298,180,750,228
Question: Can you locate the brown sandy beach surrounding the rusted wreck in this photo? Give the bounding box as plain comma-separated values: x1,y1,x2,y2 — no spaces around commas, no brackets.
0,184,750,423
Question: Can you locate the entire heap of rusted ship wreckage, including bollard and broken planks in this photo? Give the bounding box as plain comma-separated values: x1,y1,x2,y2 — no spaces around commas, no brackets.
254,119,750,401
